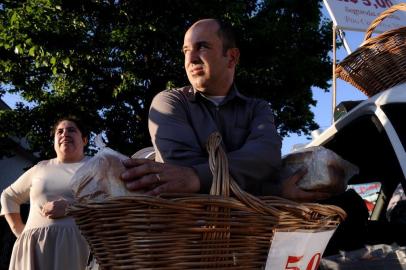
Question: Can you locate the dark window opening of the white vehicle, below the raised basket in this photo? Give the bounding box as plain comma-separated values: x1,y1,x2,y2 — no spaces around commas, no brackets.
323,114,404,220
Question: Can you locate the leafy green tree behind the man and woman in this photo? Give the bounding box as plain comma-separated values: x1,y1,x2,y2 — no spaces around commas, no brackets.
0,0,332,158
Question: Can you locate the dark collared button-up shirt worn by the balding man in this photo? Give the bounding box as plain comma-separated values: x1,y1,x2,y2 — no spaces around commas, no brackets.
149,86,281,195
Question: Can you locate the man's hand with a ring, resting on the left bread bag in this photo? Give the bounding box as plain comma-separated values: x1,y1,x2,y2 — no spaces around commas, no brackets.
121,159,200,196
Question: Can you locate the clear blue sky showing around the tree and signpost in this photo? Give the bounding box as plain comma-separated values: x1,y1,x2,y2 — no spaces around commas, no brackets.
3,5,374,155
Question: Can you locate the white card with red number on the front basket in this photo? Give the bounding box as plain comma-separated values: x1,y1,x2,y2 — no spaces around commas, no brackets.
265,230,335,270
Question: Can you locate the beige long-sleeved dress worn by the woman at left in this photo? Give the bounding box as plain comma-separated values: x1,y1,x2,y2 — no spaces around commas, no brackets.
1,158,89,270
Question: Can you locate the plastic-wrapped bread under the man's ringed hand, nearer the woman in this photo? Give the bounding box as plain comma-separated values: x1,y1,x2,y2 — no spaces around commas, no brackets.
71,147,137,202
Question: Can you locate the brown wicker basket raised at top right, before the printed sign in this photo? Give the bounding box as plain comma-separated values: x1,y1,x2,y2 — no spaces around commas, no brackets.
336,3,406,97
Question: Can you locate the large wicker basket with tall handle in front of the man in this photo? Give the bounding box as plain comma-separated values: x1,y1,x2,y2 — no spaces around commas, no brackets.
68,134,346,270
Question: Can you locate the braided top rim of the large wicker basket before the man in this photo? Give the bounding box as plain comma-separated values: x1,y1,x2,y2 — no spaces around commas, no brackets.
67,193,347,222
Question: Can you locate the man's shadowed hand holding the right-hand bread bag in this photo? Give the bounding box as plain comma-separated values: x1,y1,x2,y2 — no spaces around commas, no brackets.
280,168,331,202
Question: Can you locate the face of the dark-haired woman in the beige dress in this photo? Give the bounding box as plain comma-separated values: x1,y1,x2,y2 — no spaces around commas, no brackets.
54,120,87,162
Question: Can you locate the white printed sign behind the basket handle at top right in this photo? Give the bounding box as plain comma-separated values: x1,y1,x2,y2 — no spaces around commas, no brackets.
323,0,406,32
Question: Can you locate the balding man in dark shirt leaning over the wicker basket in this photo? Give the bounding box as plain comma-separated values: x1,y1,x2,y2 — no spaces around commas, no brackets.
122,19,325,200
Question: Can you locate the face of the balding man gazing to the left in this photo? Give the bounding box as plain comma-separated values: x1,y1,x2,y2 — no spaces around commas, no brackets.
183,21,235,95
